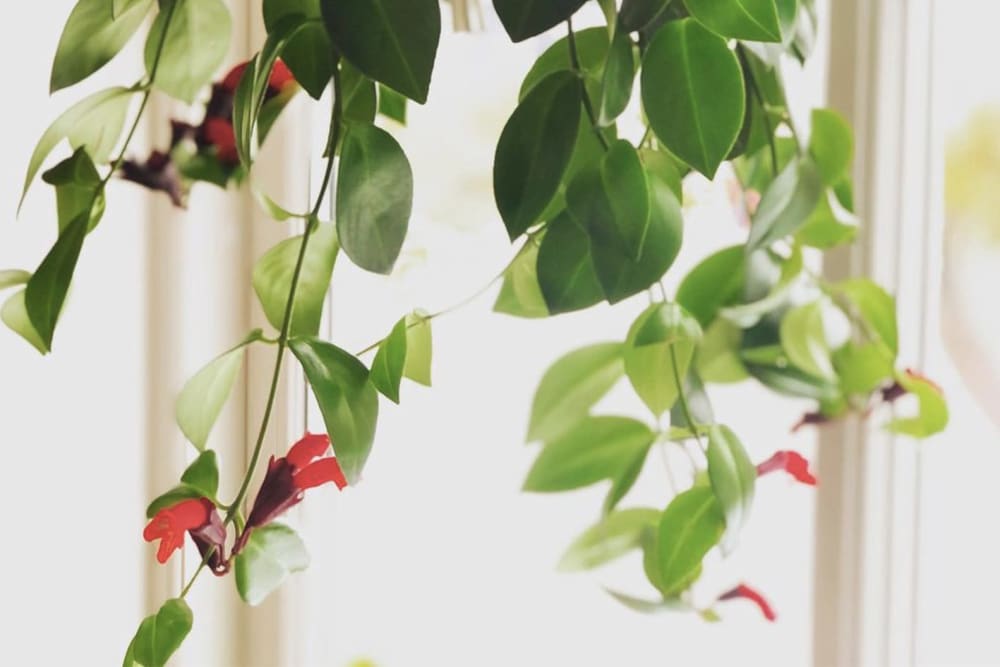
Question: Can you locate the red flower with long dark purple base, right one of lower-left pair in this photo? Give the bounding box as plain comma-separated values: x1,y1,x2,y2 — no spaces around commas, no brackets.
233,433,347,552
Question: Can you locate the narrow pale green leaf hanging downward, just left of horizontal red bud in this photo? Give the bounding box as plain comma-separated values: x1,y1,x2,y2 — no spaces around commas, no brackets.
706,426,757,553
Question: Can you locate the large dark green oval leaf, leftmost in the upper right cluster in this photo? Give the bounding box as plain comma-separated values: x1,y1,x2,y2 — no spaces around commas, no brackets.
493,71,582,240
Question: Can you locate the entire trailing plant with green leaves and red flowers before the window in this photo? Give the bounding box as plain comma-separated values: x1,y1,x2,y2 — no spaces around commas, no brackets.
0,0,948,667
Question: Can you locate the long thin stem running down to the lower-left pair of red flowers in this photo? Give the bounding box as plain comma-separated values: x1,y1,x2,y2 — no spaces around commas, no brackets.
225,68,343,524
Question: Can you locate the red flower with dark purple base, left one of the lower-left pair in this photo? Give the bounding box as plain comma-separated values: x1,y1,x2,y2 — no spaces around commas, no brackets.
142,498,229,574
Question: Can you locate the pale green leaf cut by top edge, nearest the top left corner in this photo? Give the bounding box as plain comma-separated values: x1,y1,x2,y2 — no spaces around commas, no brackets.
49,0,153,93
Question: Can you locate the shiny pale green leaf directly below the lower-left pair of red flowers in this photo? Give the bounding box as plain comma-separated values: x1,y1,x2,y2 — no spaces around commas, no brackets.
235,523,309,607
